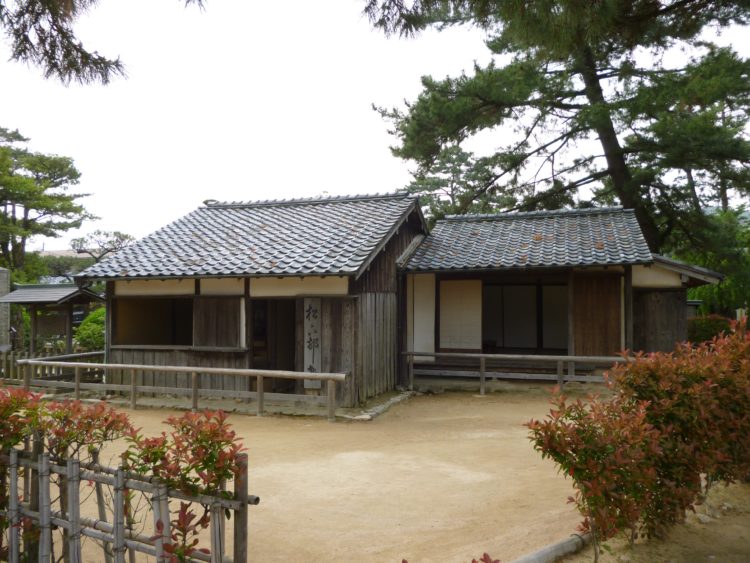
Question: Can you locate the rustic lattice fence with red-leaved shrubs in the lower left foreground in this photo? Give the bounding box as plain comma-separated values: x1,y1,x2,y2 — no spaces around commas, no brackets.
0,449,260,563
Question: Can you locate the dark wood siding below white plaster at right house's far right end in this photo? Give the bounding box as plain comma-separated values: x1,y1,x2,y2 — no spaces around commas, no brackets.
633,289,687,352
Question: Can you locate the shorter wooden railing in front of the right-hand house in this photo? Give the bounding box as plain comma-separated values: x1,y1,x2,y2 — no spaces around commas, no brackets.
403,351,633,395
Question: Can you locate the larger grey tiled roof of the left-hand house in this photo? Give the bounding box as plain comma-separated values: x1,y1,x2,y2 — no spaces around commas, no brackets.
81,194,426,279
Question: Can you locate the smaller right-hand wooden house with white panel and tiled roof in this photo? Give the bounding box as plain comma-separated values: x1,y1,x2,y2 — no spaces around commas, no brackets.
404,208,721,362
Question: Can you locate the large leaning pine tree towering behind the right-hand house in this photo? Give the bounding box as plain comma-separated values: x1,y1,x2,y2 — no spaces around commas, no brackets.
365,0,750,251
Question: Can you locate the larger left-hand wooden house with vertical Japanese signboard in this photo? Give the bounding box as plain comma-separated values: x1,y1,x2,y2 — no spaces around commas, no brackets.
77,195,427,406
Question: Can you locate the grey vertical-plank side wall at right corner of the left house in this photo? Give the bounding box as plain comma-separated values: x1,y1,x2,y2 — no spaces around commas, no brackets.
353,293,398,403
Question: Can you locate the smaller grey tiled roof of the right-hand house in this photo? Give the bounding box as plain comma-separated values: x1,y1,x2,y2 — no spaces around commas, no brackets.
406,207,653,271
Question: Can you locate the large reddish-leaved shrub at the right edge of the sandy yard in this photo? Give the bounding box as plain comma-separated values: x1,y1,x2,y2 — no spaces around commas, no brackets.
528,323,750,556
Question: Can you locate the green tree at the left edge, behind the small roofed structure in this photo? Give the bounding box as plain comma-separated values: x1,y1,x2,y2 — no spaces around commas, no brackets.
0,128,95,270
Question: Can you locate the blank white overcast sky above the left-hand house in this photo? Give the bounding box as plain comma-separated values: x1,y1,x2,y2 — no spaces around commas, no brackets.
0,0,489,250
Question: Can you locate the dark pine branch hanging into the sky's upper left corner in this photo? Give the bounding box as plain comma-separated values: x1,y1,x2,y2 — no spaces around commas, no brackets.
0,0,203,84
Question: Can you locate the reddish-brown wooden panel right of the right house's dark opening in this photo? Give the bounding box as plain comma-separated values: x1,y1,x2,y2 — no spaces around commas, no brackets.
572,272,622,356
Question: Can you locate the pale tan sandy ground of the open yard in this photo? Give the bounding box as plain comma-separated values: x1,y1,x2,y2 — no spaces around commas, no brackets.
87,390,579,563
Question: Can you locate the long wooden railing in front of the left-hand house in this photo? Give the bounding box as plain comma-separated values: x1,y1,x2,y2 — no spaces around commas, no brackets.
17,357,347,422
